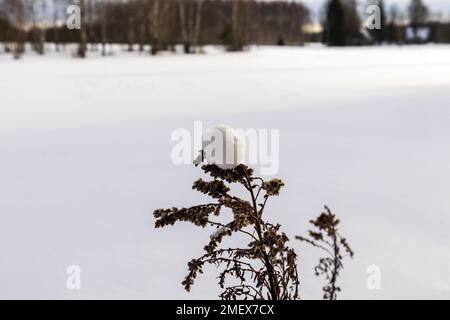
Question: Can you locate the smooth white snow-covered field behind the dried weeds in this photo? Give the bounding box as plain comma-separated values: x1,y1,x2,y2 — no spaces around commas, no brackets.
0,46,450,299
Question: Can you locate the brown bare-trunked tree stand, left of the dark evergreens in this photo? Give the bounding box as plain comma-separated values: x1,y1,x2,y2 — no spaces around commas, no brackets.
0,0,310,57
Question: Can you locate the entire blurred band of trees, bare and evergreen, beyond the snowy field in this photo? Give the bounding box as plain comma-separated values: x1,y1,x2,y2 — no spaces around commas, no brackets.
0,0,450,58
